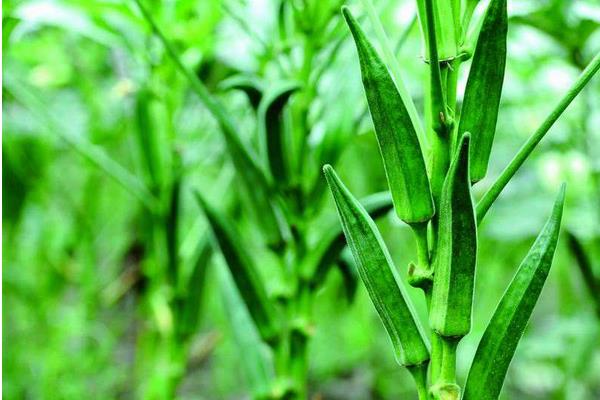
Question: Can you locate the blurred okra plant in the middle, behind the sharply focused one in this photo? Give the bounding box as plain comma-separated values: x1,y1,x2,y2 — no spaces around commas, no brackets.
137,0,398,399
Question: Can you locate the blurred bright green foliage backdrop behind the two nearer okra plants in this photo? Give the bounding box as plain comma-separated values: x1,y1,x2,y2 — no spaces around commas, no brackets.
2,0,600,399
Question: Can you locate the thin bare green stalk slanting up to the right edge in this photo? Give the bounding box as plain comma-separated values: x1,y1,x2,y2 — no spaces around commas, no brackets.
477,53,600,224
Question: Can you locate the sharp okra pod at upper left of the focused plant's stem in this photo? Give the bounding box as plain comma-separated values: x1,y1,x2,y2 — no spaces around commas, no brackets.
342,7,434,223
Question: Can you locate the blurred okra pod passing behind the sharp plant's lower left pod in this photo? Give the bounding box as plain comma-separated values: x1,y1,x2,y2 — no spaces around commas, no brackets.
301,192,393,289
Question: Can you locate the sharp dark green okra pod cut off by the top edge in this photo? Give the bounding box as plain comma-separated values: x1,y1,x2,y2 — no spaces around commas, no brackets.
458,0,508,182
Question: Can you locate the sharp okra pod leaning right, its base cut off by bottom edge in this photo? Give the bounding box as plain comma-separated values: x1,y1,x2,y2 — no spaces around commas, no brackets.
463,184,565,400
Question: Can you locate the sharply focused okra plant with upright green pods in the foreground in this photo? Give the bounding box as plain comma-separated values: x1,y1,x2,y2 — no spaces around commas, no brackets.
323,0,600,400
